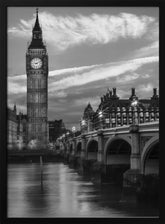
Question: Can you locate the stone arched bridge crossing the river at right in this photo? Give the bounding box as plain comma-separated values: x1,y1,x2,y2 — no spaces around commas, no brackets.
59,121,159,187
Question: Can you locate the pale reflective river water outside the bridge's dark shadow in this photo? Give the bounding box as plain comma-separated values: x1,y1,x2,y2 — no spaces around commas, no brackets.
8,163,158,218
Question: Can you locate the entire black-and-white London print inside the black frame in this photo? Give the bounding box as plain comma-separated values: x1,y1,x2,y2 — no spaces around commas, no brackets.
4,5,160,218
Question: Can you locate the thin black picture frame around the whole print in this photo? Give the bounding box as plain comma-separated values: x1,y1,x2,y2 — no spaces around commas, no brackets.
0,0,165,224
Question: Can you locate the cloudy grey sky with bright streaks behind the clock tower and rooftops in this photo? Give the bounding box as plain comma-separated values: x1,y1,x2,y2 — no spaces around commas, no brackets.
8,7,159,128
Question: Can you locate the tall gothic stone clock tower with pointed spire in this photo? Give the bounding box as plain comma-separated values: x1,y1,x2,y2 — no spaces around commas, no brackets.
26,9,48,148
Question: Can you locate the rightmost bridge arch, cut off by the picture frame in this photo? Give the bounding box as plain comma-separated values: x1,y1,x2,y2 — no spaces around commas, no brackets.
141,136,159,175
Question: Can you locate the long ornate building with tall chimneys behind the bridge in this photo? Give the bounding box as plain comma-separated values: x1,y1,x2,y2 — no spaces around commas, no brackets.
81,88,159,131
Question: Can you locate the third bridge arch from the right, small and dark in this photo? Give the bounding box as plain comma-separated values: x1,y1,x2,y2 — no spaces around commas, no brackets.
86,139,98,160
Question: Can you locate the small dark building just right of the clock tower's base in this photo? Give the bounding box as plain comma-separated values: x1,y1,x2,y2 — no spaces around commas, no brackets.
49,119,66,143
